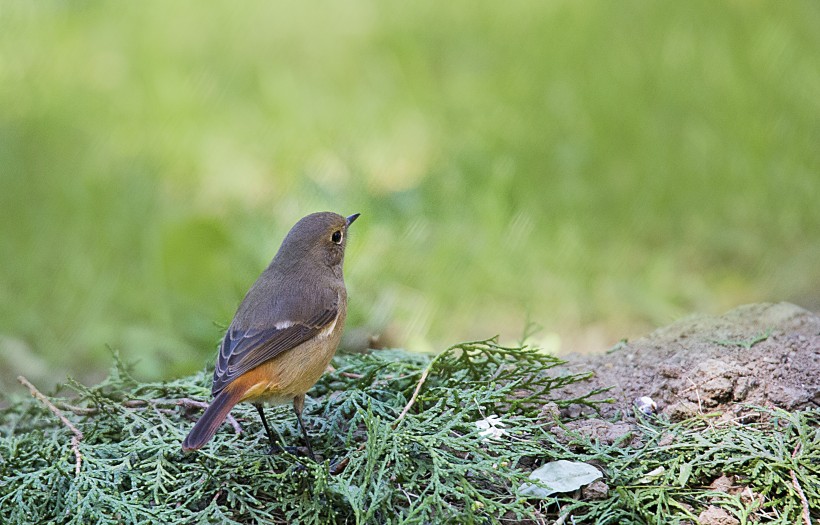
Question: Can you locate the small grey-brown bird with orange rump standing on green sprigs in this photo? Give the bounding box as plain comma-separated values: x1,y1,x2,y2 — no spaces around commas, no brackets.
182,212,360,461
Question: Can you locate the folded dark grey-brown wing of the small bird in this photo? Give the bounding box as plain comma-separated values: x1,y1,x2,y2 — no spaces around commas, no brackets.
211,301,339,395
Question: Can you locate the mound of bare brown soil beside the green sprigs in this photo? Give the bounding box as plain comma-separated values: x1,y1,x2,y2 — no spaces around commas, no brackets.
567,303,820,420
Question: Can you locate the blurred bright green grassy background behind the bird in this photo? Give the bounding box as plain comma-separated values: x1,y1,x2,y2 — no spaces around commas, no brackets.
0,0,820,382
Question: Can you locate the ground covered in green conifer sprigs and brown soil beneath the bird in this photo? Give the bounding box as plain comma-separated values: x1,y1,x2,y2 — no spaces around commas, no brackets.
0,303,820,525
